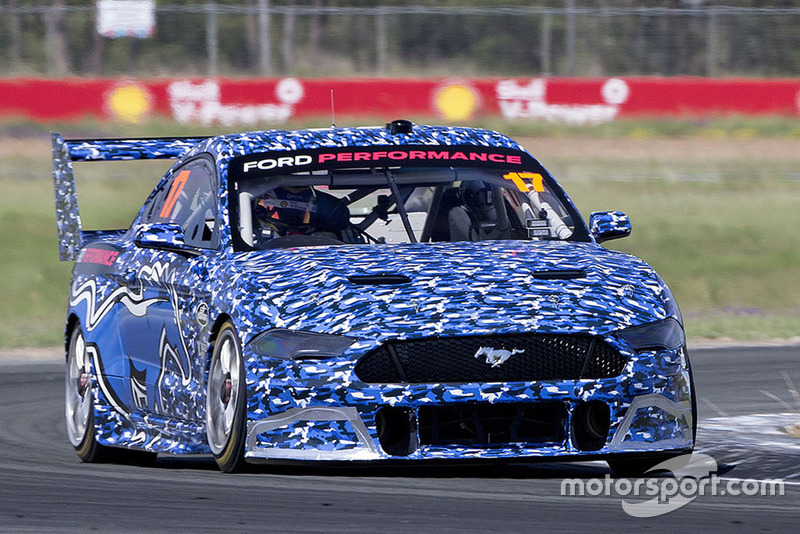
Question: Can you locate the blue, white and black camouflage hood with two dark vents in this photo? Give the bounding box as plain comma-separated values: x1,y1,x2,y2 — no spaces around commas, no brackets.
225,241,676,339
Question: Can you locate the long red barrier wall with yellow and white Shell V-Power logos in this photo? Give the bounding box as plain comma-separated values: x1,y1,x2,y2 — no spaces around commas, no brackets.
0,78,800,125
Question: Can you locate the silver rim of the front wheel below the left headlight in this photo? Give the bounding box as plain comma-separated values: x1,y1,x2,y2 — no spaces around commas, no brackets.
206,332,241,455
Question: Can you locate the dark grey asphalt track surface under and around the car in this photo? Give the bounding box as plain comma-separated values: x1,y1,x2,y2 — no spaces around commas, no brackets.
0,347,800,533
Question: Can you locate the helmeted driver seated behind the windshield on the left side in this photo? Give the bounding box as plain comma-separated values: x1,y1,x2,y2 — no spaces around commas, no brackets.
253,186,350,237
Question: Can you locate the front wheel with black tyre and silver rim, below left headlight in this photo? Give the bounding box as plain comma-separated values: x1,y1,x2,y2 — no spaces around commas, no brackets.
206,322,247,473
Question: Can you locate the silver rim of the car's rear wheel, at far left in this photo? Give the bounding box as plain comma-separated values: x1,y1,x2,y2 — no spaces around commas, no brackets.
65,332,92,447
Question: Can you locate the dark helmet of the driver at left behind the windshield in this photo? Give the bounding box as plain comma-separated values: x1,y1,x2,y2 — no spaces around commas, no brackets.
254,187,317,236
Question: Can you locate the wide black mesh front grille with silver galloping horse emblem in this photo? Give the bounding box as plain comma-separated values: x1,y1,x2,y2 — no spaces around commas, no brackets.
355,334,625,384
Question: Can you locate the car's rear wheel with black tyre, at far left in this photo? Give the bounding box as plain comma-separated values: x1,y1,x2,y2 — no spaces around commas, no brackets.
64,326,157,465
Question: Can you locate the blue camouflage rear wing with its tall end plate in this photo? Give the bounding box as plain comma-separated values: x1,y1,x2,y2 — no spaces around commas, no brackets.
52,133,208,261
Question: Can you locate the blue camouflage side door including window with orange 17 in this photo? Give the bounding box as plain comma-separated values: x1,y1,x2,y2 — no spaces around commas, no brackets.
118,157,219,420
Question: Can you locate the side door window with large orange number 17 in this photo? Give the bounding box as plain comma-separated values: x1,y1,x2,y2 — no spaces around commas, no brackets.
143,157,219,248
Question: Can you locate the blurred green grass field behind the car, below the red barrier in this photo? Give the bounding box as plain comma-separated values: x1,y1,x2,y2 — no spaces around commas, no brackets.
0,119,800,347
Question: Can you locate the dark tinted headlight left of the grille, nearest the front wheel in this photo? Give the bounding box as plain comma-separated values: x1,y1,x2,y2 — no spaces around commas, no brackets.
249,328,358,360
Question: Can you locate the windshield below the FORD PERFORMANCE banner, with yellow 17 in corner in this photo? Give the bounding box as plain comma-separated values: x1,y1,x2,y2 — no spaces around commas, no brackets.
231,151,588,250
